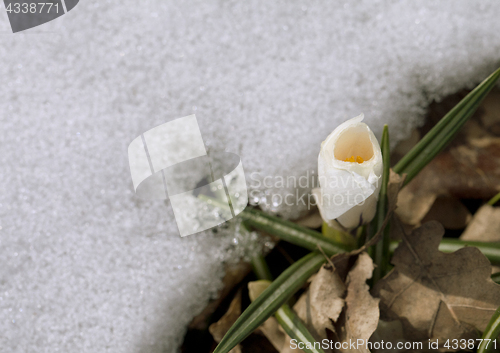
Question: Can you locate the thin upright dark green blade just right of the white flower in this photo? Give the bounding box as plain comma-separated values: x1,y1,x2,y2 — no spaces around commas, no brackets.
372,125,391,283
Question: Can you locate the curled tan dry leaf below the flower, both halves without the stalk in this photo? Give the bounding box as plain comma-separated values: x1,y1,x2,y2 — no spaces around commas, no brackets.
292,252,379,352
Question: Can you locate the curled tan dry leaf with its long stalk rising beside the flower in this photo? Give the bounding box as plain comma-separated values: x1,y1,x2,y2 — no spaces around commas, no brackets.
286,169,405,350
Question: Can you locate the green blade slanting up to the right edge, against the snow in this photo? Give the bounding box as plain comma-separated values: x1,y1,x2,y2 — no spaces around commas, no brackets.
393,65,500,184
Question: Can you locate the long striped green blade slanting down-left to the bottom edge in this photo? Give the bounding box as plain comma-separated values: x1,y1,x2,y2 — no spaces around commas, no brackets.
214,252,326,353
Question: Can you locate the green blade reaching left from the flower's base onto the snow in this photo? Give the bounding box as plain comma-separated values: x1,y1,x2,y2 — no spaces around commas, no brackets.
240,208,353,256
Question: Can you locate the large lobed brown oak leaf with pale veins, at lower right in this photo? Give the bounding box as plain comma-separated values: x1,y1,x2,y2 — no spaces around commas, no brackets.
373,221,500,343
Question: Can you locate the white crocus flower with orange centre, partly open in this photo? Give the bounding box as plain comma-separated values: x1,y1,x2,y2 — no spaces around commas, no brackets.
313,114,383,229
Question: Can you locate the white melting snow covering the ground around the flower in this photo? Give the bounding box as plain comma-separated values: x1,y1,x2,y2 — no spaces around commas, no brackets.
0,0,500,353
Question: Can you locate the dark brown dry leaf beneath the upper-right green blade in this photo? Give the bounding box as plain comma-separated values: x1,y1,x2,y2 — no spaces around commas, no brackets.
396,116,500,229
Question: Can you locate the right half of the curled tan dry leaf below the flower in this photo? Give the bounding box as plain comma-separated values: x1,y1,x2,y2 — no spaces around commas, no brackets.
335,252,380,353
